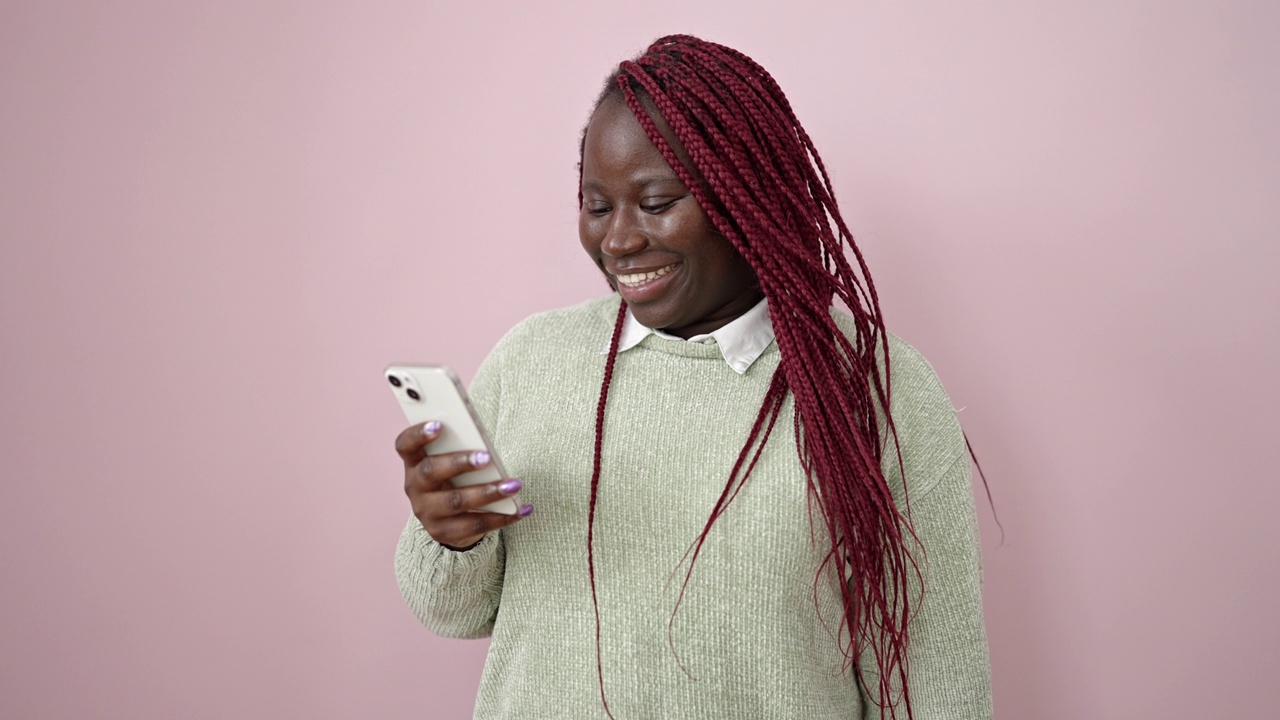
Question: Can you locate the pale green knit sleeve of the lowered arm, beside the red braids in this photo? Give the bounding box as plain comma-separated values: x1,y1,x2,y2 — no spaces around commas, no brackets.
859,341,992,720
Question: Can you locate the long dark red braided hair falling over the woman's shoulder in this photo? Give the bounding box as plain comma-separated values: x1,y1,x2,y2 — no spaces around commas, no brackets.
579,35,919,719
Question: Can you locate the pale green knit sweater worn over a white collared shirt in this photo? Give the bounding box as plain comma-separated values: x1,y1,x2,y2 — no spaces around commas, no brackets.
396,295,991,720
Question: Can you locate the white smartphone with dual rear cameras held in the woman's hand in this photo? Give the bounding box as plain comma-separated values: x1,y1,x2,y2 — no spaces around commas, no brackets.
384,364,520,515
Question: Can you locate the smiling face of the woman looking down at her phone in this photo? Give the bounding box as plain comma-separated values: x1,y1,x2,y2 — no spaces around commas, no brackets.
577,95,760,337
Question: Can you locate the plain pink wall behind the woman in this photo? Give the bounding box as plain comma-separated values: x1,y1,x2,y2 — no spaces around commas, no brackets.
0,0,1280,720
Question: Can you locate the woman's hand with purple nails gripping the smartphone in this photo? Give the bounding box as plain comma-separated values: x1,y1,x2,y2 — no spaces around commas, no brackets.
396,420,534,550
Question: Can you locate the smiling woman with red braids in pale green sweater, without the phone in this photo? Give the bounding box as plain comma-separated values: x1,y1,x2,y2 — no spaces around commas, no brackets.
397,36,991,720
